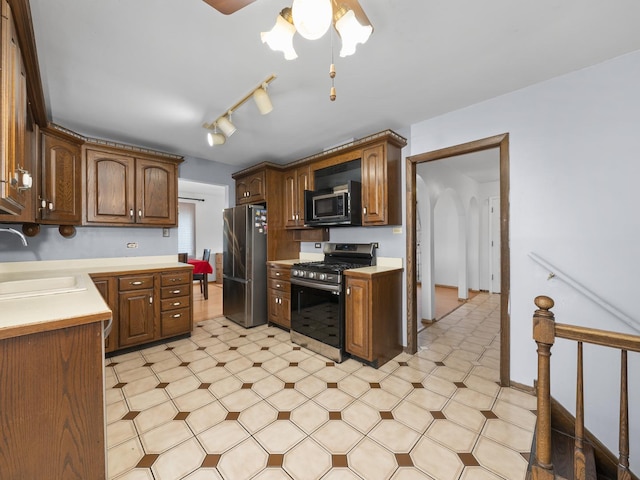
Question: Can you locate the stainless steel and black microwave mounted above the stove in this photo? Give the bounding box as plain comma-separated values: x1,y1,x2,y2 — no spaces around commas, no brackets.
304,181,362,227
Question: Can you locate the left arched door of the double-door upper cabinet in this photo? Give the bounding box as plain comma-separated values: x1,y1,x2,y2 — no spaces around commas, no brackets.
86,150,135,224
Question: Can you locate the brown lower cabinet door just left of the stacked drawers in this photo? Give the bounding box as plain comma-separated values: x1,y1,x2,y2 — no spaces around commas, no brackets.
118,289,155,347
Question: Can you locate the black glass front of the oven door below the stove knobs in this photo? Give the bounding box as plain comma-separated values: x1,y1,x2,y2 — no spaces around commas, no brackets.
291,283,344,349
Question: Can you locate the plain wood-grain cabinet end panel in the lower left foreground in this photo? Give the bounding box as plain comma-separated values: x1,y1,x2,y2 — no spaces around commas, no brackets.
0,321,106,480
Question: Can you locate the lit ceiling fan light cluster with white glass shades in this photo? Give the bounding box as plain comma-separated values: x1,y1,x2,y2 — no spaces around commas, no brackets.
260,0,373,60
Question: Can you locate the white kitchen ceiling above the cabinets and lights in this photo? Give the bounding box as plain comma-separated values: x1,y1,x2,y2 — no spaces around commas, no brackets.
30,0,640,169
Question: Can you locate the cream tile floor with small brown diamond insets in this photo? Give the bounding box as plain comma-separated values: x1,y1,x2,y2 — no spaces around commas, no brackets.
106,294,536,480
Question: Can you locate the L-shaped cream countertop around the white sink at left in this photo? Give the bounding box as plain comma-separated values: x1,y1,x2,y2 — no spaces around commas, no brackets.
0,255,191,339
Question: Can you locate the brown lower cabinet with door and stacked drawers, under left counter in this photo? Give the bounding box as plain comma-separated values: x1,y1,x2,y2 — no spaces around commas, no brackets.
91,267,193,353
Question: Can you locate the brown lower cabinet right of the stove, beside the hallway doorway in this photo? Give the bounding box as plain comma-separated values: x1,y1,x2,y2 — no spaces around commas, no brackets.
345,269,402,367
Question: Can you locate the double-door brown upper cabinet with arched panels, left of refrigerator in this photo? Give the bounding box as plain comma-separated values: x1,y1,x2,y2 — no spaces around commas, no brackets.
85,145,182,227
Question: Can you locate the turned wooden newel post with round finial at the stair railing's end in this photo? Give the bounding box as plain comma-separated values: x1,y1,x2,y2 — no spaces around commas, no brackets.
532,296,555,480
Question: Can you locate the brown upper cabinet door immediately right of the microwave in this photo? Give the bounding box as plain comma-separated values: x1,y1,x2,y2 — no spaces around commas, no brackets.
362,145,387,225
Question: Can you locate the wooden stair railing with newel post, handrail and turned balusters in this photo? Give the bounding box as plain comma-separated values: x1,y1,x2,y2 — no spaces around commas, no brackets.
531,296,640,480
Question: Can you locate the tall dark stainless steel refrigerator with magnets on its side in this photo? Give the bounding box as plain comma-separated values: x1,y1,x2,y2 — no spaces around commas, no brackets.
222,205,267,327
